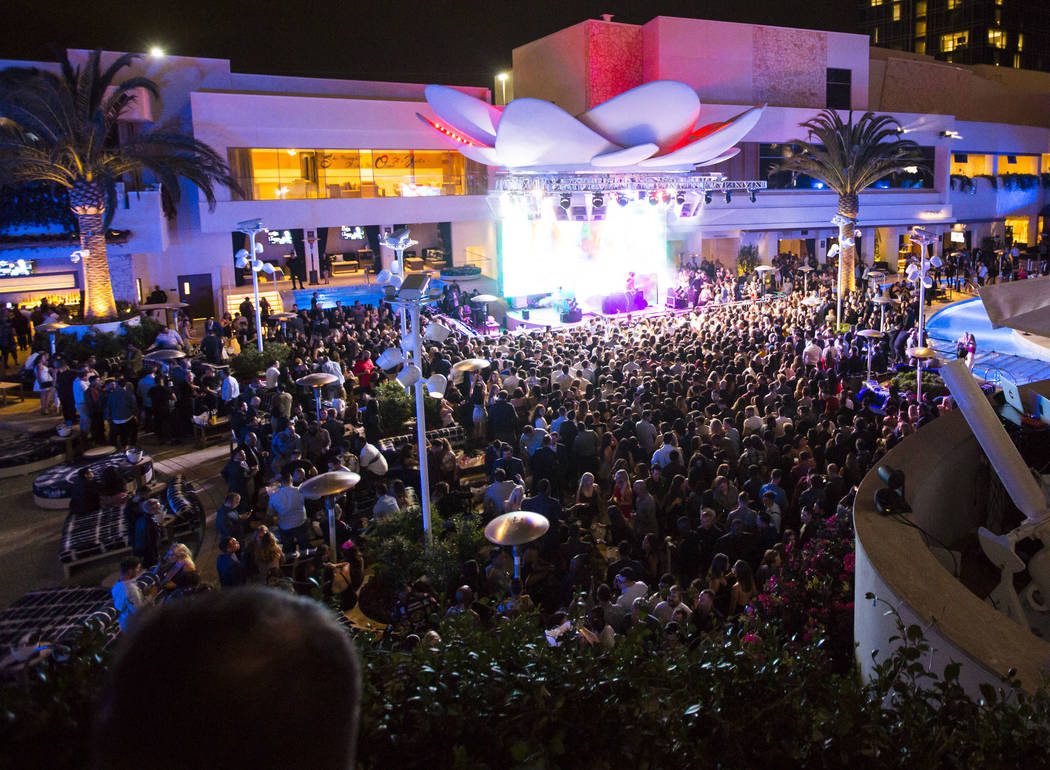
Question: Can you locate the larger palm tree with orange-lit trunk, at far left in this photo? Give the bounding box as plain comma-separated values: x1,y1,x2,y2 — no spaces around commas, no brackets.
0,50,237,318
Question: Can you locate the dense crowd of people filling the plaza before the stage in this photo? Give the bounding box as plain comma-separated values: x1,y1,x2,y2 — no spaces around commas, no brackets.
4,258,950,645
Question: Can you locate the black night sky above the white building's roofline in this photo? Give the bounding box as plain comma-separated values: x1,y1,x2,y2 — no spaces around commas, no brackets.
8,0,858,87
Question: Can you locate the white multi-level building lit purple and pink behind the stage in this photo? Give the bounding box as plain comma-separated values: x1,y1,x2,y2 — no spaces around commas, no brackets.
0,17,1050,315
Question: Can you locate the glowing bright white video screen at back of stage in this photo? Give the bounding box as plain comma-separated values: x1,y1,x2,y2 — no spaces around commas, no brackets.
501,202,668,306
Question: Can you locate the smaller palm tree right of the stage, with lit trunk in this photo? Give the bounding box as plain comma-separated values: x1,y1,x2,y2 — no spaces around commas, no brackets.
774,109,922,322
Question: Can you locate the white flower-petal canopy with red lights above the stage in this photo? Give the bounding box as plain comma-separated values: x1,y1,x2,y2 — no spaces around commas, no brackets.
417,80,765,171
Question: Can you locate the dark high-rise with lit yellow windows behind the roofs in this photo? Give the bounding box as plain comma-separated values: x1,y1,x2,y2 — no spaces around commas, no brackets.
859,0,1050,71
